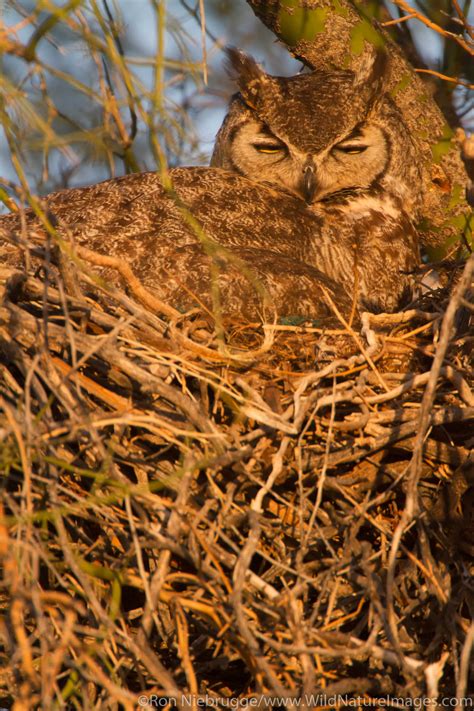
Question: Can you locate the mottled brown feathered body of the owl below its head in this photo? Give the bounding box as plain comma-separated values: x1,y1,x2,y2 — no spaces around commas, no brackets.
0,168,418,317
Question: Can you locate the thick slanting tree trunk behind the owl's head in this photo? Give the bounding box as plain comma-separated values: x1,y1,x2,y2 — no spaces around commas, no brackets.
247,0,471,255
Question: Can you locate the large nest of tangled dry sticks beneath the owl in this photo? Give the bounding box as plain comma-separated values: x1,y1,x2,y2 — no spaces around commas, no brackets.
0,248,474,709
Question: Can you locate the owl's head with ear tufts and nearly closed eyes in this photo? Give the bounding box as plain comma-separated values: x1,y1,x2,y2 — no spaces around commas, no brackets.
211,49,418,214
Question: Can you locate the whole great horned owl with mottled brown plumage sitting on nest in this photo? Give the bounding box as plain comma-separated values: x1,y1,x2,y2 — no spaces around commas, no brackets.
0,52,418,317
